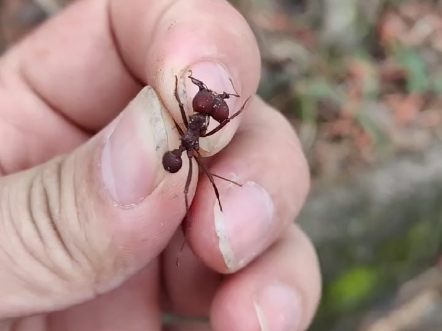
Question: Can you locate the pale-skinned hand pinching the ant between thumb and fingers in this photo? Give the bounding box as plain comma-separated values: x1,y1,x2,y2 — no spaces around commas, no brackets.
0,0,321,331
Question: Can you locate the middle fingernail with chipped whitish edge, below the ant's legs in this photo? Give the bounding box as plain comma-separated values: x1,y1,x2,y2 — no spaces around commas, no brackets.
214,182,275,272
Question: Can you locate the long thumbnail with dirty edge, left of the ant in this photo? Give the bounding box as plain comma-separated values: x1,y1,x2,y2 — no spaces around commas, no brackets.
101,87,167,206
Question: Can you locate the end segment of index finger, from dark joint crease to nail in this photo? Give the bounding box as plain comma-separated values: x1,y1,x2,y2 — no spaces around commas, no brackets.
111,0,261,156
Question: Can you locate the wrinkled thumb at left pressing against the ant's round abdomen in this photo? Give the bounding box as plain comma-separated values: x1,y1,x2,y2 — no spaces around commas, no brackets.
0,87,190,319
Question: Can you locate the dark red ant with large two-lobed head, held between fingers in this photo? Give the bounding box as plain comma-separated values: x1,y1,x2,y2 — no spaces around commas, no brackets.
163,71,250,266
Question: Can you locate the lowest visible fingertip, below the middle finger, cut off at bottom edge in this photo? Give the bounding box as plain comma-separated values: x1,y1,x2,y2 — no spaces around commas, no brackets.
211,225,321,331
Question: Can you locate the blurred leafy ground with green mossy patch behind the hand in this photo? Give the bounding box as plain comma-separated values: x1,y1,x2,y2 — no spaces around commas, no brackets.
0,0,442,331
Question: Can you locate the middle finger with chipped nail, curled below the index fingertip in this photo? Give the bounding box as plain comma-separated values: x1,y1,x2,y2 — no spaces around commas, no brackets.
189,98,309,273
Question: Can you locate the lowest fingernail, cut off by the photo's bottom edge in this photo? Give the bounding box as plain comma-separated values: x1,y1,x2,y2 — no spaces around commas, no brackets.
254,284,302,331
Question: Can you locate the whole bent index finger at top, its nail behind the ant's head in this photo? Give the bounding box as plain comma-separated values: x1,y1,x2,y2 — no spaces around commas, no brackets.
0,0,260,154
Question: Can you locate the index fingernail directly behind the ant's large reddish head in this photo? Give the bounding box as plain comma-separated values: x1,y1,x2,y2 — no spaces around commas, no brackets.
179,61,241,154
